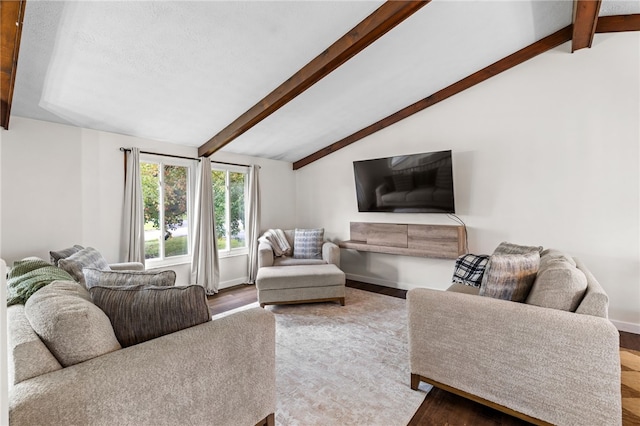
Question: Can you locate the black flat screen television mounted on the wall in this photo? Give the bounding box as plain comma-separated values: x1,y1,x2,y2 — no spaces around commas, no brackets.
353,151,455,213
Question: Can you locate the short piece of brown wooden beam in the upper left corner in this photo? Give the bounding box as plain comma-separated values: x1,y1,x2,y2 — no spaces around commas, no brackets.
0,0,27,130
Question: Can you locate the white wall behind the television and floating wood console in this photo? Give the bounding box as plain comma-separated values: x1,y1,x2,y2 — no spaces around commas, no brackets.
296,33,640,332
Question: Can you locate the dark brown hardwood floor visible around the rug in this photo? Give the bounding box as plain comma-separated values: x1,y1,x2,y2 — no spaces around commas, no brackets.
208,280,640,426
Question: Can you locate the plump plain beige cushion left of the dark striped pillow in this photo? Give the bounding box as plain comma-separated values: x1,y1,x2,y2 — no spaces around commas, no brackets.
24,281,120,367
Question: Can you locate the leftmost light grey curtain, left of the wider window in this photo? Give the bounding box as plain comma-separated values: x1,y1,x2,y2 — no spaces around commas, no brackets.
120,148,144,264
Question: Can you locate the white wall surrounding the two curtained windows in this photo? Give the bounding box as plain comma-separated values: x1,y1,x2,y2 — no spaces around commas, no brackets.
0,116,295,288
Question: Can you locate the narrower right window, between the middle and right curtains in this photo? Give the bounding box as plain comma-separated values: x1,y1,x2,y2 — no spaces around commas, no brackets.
211,164,249,254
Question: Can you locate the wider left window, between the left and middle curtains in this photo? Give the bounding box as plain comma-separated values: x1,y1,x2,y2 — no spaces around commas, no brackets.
140,158,192,263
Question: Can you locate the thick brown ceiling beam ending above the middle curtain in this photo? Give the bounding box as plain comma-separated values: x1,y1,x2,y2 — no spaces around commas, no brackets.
198,0,430,157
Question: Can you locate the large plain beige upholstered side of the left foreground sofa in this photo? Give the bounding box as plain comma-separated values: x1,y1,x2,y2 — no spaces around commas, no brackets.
9,308,276,425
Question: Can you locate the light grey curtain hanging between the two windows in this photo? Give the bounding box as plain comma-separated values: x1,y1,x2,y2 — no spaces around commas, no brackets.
191,157,220,295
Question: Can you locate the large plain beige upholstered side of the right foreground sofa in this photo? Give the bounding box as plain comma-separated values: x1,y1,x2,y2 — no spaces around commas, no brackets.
407,289,621,425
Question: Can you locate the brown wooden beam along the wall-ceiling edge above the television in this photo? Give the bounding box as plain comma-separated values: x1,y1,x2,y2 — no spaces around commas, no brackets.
293,25,572,170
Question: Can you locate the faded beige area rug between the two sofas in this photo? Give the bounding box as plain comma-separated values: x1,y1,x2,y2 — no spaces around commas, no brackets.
214,288,431,426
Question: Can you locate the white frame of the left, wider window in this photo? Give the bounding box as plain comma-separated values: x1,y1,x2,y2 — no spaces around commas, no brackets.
140,154,196,269
